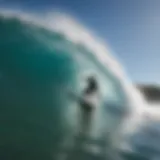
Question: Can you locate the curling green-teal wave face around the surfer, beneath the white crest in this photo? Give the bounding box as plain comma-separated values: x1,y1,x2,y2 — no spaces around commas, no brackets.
0,10,146,160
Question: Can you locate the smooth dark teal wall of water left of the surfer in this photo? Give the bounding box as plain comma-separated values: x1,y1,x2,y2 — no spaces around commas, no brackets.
0,14,79,159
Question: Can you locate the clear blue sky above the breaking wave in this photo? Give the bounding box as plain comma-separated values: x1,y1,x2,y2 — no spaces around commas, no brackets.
0,0,160,84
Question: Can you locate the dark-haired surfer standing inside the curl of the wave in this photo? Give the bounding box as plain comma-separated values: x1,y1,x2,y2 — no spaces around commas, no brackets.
66,76,99,134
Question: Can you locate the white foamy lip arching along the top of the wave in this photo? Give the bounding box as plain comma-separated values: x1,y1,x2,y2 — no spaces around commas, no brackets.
0,9,149,145
